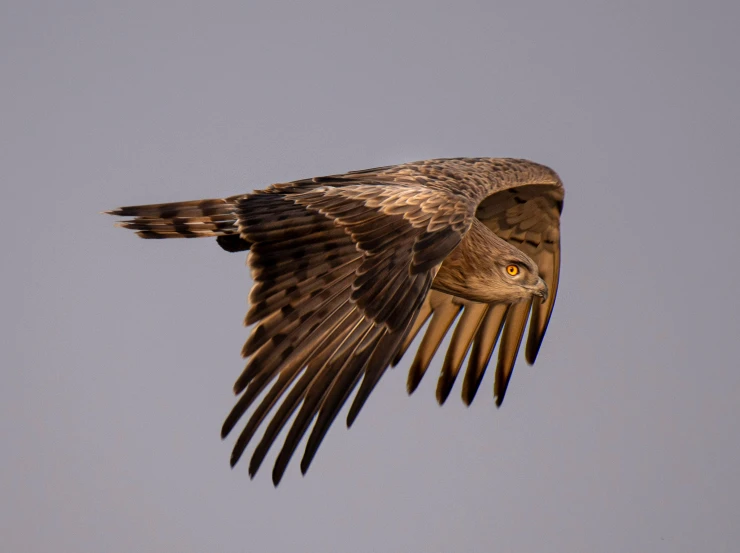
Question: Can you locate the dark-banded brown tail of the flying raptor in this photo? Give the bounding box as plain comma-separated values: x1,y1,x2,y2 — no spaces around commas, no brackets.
105,196,238,238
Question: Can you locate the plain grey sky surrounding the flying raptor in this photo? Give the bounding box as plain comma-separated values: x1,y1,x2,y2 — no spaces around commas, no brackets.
0,0,740,553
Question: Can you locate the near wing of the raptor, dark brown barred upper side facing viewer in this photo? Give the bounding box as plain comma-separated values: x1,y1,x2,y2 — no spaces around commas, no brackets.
222,178,475,484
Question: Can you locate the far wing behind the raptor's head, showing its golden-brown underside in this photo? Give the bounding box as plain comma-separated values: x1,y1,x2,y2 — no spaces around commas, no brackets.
393,177,564,405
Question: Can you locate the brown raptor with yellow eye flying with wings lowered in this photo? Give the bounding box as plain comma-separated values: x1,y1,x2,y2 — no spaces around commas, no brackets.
105,157,565,486
